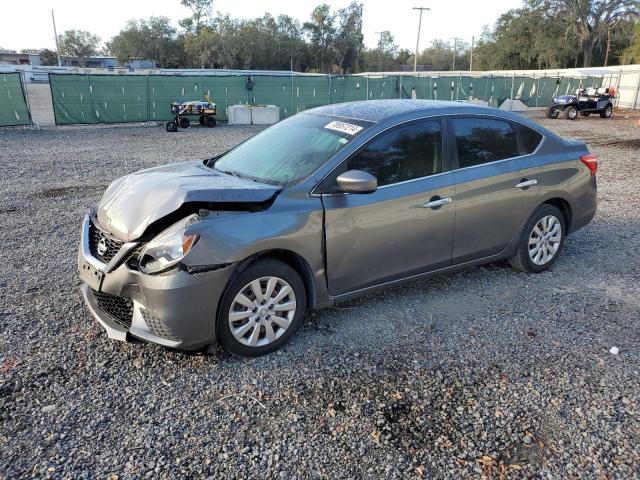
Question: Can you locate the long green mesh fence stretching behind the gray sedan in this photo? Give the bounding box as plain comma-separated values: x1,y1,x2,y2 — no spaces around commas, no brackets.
48,74,603,125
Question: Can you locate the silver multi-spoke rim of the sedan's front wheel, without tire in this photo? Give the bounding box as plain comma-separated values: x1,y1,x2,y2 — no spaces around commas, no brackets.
229,277,296,347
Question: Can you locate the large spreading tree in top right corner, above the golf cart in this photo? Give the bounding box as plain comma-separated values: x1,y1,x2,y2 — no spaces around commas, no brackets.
541,0,639,67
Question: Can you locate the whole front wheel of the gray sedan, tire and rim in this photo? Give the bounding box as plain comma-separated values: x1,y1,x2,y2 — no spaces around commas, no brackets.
218,259,307,357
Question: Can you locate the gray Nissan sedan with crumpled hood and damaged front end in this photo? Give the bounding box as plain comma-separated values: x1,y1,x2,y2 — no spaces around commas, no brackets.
78,100,597,356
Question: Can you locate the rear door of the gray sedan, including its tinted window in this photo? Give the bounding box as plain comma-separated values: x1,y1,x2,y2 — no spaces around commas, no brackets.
450,116,540,264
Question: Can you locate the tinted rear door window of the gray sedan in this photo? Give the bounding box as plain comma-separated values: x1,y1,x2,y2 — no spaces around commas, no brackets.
452,117,520,168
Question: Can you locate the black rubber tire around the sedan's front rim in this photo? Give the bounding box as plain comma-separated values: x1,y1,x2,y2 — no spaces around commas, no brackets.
217,259,307,357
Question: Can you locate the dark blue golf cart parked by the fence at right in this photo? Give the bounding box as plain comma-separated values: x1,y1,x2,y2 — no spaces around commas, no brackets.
547,87,616,120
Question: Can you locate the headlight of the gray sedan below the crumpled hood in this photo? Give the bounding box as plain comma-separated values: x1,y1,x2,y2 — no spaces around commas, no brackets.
140,216,200,273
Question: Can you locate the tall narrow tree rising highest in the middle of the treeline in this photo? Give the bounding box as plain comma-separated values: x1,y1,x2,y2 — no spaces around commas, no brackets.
334,2,364,73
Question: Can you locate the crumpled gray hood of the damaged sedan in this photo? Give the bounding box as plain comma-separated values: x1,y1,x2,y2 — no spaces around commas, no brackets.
97,161,280,242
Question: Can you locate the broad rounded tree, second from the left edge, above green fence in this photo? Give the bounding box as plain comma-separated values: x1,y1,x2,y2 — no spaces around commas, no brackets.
107,17,184,68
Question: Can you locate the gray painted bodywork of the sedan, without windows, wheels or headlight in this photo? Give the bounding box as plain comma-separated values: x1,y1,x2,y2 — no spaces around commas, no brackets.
78,100,596,348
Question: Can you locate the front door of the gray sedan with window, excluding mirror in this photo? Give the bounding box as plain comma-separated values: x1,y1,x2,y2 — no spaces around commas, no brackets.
322,119,455,296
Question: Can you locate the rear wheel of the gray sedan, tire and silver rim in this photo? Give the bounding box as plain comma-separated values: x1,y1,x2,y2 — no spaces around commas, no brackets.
509,204,567,273
